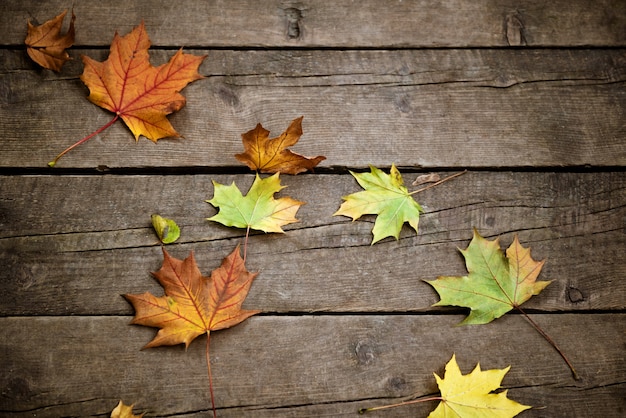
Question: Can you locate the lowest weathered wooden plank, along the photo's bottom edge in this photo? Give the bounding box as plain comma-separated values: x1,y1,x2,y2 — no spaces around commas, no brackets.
0,314,626,417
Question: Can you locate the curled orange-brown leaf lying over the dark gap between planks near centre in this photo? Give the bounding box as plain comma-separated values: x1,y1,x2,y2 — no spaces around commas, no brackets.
235,116,326,174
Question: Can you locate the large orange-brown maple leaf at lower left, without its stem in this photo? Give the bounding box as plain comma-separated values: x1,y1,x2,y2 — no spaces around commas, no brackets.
124,246,260,348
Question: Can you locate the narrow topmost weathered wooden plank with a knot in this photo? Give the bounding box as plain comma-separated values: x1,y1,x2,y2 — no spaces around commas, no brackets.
0,0,626,48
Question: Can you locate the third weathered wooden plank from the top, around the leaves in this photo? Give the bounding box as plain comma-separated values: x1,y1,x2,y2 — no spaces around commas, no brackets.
0,172,626,315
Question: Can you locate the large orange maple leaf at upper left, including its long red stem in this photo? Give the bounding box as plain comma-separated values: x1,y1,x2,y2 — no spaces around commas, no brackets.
48,22,206,167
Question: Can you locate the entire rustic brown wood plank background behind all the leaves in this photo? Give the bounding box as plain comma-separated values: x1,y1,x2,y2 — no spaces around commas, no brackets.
0,0,626,417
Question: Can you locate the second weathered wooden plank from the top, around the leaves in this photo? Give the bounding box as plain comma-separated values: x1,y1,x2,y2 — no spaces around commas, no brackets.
0,50,626,168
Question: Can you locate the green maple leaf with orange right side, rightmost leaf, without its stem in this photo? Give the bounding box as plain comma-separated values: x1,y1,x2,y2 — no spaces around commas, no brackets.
426,230,550,324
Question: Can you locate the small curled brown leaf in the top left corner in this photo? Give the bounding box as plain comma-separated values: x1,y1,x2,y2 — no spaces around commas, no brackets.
24,10,76,72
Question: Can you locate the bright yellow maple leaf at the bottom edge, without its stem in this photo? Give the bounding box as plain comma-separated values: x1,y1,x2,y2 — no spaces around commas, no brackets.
428,355,531,418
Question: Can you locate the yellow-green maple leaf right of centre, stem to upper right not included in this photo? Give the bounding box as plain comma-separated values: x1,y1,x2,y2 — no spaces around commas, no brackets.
333,165,422,244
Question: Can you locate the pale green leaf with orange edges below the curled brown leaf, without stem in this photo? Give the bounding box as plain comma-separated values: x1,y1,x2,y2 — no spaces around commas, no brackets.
206,173,304,233
